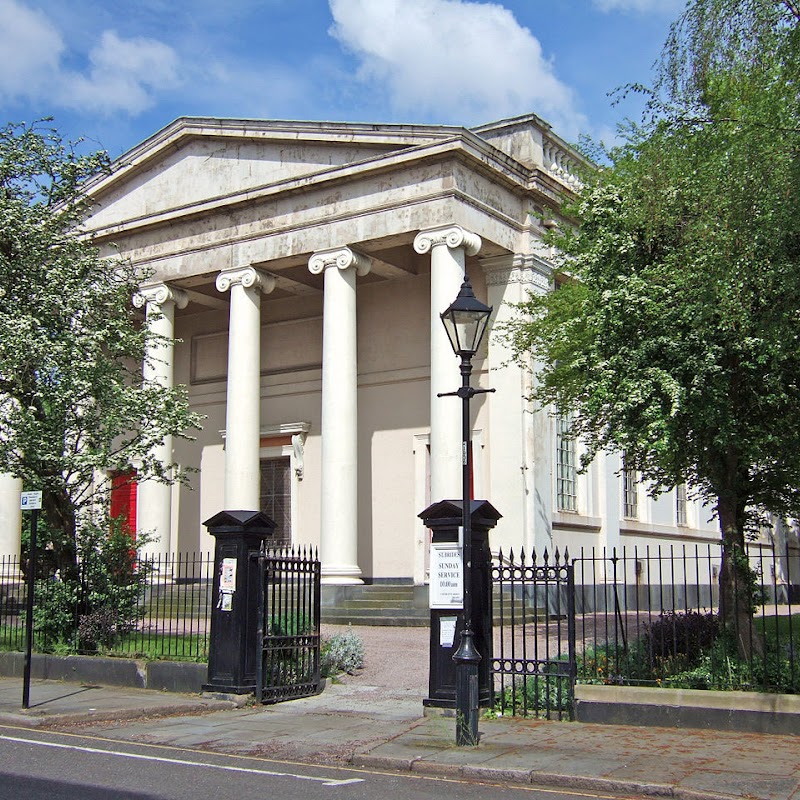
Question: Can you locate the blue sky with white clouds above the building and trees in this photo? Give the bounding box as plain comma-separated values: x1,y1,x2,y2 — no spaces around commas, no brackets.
0,0,684,161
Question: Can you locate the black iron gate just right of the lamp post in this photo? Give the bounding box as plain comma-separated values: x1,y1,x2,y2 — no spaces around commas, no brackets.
492,550,576,719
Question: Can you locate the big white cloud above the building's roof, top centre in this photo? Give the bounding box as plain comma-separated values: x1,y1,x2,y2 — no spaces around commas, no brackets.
329,0,585,137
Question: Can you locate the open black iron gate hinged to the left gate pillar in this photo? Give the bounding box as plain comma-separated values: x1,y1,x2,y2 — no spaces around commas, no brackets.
256,547,320,703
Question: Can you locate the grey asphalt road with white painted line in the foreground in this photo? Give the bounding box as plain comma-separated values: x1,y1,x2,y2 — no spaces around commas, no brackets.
0,728,624,800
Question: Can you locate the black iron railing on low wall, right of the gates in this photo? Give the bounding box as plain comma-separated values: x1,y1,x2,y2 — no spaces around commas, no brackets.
573,543,800,693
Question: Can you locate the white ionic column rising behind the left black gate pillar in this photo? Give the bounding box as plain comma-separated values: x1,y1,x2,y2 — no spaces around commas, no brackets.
217,267,275,511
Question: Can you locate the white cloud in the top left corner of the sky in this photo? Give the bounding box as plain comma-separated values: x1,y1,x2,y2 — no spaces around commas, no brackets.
0,0,179,114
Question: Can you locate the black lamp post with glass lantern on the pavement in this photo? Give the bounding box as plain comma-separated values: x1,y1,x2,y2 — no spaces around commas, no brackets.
439,277,494,745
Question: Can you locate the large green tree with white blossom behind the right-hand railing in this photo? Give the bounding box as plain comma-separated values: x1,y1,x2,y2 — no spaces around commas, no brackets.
508,0,800,653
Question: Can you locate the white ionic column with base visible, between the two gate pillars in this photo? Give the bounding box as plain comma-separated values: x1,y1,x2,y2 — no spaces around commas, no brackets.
308,247,370,584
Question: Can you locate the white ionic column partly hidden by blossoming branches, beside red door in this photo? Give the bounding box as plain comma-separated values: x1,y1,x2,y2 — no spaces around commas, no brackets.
133,283,188,556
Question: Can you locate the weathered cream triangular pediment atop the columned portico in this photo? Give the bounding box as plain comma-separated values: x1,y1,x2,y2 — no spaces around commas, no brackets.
88,118,461,229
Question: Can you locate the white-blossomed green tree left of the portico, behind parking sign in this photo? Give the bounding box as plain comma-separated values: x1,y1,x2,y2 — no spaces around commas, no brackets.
0,123,199,576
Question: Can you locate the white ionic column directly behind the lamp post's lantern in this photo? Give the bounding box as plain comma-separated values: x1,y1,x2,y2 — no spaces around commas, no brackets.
414,225,481,502
